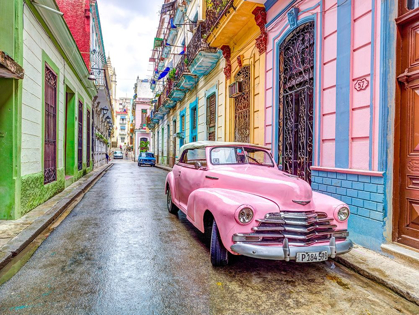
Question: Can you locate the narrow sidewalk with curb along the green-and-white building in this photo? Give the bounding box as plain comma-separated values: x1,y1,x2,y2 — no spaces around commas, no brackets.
0,164,113,271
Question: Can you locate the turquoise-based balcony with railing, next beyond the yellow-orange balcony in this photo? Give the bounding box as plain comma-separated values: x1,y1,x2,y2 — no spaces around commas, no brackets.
187,23,221,78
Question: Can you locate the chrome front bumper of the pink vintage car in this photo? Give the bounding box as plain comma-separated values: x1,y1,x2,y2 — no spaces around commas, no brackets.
231,237,353,261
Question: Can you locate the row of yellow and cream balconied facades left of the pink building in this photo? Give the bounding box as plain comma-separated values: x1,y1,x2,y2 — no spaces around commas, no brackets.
148,0,267,166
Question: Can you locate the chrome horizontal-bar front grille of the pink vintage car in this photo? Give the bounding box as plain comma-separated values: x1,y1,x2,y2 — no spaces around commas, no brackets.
233,211,349,246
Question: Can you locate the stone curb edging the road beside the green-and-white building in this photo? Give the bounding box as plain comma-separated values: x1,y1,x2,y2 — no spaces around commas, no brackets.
0,164,113,271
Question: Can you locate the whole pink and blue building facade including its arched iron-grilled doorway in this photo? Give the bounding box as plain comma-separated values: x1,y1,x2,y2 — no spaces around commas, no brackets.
265,0,396,250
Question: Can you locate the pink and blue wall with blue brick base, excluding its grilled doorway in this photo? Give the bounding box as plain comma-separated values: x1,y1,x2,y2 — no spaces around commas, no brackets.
265,0,387,249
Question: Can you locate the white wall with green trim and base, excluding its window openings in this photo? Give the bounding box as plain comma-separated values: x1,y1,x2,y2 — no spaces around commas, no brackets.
20,6,93,215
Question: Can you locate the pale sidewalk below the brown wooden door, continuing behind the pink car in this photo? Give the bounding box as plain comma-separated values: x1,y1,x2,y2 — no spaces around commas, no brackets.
156,164,419,305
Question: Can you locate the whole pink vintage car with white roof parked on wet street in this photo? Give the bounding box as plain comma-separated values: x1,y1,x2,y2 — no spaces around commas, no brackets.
166,141,353,266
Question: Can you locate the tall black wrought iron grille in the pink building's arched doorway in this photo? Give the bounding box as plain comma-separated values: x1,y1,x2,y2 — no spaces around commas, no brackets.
278,22,314,183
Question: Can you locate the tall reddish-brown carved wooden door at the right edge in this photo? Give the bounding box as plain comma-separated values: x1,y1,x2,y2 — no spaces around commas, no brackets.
394,4,419,249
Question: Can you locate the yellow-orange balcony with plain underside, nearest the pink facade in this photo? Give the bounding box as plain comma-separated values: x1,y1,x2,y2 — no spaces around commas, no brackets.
206,0,264,48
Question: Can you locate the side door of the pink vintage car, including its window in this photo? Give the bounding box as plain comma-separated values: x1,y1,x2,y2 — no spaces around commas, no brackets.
175,149,206,213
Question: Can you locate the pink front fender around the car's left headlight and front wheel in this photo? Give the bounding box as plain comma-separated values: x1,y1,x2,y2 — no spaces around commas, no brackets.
186,188,279,252
